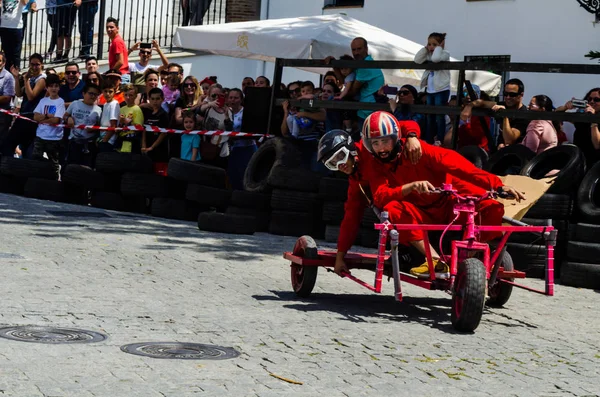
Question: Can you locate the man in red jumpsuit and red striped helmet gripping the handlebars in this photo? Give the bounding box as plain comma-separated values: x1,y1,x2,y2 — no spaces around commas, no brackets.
363,112,525,278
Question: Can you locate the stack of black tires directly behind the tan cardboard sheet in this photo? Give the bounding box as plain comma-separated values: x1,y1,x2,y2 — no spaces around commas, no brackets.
507,145,585,278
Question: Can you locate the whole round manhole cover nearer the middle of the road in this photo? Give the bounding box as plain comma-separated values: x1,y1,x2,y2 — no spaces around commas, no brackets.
121,342,240,360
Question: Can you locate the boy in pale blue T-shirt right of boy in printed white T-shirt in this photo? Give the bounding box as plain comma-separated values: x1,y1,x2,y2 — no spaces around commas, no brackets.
64,83,102,167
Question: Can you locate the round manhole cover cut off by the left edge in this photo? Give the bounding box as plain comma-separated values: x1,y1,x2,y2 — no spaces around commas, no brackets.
0,325,107,344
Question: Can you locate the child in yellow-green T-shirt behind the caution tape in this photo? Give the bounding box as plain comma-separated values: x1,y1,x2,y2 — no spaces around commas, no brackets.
117,84,144,154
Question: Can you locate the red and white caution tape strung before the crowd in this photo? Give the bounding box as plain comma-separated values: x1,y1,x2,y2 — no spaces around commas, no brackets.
0,109,270,138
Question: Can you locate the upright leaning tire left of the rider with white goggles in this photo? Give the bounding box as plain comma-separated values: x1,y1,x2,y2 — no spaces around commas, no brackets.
244,138,302,193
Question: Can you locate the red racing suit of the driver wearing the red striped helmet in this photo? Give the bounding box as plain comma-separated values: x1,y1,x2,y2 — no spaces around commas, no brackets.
367,142,504,245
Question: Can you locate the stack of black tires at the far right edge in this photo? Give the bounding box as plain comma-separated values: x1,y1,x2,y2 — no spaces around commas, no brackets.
560,163,600,289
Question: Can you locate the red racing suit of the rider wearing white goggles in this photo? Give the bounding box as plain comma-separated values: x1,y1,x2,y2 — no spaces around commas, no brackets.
337,120,424,252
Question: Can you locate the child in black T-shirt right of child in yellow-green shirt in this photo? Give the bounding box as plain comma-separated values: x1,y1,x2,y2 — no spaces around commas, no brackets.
142,88,169,163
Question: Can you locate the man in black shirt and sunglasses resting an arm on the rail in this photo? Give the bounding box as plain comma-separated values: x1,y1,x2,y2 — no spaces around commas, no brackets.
463,79,529,149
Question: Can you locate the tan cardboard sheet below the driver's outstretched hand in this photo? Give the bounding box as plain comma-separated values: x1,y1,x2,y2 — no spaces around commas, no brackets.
498,175,554,220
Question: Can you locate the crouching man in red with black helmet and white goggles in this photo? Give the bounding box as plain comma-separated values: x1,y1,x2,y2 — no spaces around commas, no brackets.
317,121,421,275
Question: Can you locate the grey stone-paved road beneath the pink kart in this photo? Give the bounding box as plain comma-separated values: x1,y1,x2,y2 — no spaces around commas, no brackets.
0,195,600,397
